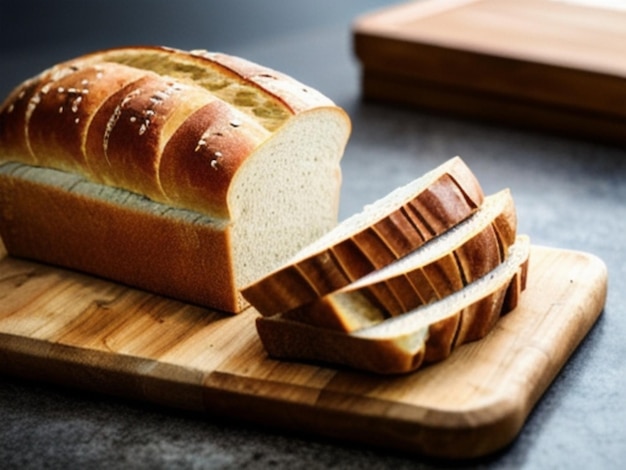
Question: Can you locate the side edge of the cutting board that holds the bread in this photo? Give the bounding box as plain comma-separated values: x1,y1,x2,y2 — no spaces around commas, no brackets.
0,246,608,459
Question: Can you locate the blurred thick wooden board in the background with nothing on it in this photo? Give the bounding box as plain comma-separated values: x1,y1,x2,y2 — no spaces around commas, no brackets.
353,0,626,143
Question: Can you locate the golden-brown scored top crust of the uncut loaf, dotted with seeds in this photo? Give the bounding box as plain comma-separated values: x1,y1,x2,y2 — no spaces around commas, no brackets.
0,47,349,218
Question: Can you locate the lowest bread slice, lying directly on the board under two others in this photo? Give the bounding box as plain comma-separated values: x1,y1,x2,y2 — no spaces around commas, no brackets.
256,235,530,374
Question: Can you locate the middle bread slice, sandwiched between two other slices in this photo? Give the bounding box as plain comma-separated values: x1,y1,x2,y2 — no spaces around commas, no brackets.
282,189,517,332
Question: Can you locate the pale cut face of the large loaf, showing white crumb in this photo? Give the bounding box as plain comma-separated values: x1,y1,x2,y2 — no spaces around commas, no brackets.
228,108,350,286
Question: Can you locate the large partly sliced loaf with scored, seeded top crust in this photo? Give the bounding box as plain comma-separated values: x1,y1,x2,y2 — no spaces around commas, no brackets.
0,47,350,312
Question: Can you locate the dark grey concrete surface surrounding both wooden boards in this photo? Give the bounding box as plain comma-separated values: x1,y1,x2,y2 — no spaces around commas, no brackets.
0,0,626,470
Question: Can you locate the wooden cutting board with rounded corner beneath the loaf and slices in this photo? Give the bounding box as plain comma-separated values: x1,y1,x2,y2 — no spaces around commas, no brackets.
0,242,607,458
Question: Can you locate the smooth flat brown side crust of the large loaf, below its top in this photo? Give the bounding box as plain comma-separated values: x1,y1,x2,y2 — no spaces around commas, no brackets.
0,169,236,312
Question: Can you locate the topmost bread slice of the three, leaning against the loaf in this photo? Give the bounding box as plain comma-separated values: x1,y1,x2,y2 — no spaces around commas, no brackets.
242,157,484,316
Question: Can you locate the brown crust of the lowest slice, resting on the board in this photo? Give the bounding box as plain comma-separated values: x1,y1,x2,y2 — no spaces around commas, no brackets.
256,246,528,375
